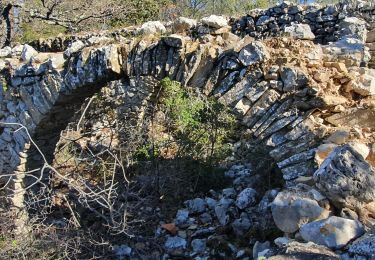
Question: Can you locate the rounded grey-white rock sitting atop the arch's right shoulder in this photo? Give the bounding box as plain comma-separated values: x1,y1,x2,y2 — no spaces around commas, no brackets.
238,41,269,66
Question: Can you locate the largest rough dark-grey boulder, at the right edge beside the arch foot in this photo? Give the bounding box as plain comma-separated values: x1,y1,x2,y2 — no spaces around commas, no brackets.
314,144,375,211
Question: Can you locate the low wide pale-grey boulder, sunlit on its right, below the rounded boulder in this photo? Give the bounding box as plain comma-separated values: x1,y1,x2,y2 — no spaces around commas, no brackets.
300,216,364,249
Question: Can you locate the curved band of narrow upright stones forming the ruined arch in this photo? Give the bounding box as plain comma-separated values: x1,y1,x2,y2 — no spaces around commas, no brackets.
0,20,374,232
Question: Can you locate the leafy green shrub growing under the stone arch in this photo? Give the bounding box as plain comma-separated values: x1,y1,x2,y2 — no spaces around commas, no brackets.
161,78,235,162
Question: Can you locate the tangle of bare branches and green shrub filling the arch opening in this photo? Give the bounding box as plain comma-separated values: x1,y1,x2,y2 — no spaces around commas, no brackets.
0,78,236,259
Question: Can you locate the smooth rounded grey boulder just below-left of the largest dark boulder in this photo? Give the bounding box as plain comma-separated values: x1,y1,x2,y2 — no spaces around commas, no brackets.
271,185,324,233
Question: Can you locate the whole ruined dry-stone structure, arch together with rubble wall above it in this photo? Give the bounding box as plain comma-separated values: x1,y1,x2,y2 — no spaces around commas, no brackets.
0,1,375,258
